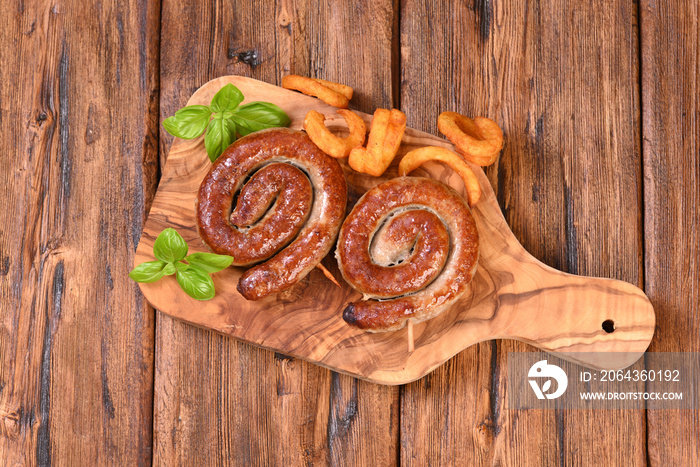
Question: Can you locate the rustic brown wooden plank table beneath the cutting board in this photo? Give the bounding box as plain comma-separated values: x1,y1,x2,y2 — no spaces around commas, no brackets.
0,0,700,465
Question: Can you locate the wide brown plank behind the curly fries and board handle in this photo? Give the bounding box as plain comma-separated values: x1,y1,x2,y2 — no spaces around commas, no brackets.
401,1,645,465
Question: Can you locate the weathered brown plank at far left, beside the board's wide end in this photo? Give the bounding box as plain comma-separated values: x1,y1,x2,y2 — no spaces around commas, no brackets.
0,0,159,465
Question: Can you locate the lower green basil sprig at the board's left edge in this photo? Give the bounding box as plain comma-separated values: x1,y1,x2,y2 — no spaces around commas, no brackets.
129,228,233,300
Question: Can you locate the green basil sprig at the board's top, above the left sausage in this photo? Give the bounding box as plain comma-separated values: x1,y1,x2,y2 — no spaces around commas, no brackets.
163,83,291,162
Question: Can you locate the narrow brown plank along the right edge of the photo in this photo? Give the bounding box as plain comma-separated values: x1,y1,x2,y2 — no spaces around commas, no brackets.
640,0,700,465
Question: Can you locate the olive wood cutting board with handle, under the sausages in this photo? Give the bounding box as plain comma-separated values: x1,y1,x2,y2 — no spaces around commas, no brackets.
135,76,655,384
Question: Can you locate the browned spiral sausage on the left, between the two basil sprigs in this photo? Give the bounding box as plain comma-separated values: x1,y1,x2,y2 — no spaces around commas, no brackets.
196,128,347,300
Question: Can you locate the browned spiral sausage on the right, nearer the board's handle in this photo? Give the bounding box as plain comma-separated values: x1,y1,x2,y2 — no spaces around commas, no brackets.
336,177,479,332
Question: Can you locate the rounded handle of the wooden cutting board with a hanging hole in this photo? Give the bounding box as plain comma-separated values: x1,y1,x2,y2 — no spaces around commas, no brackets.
486,254,656,369
